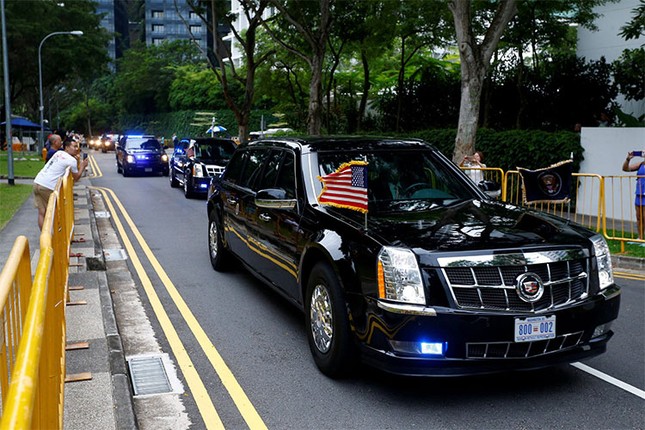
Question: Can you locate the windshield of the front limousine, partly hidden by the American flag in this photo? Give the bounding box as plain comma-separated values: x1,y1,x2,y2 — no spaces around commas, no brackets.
318,149,479,212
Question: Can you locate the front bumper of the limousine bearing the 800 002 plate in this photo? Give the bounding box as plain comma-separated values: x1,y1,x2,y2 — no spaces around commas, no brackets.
356,286,620,376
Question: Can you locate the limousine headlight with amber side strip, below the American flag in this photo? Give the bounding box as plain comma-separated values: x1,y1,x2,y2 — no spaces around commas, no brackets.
377,246,426,305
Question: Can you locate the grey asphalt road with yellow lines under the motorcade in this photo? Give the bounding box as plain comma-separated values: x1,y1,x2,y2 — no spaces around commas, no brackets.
90,151,645,429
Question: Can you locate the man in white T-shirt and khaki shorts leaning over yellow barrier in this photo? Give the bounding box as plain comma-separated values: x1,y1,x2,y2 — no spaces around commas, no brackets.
34,137,89,230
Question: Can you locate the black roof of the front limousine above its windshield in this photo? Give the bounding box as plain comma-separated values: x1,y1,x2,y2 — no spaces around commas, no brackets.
240,136,436,152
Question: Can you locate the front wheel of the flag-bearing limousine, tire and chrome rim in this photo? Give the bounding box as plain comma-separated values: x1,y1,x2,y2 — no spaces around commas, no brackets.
305,263,358,378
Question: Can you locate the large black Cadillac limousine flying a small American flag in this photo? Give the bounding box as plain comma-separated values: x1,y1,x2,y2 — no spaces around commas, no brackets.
207,138,620,377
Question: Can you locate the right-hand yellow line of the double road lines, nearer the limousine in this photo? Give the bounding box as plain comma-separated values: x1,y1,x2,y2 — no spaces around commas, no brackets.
92,188,267,429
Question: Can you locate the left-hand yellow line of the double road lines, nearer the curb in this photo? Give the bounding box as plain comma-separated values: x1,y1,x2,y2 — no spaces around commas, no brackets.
91,187,225,429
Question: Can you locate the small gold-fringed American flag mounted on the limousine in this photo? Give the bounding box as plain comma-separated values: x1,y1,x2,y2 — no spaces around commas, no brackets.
318,160,367,213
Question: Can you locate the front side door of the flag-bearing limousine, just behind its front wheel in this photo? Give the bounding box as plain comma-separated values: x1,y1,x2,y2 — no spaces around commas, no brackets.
247,149,302,300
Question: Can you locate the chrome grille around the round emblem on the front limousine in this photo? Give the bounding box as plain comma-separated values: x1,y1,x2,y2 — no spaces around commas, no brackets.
442,258,589,312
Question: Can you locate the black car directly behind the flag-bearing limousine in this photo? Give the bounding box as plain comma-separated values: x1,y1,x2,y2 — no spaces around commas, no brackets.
168,137,237,198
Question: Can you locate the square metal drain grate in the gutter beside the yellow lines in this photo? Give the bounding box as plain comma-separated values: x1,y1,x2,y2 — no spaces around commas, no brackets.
128,355,178,396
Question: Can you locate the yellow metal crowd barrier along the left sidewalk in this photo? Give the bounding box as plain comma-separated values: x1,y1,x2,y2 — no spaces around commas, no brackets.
0,170,74,430
